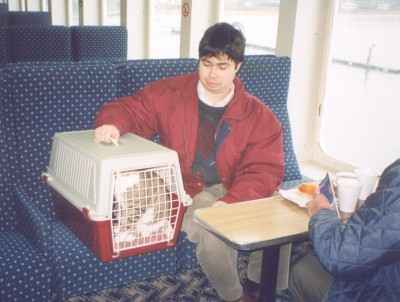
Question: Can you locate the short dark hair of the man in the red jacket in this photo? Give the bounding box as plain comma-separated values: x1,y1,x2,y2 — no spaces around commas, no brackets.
199,23,246,63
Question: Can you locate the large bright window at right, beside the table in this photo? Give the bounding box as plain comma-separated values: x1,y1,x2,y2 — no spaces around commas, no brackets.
320,0,400,170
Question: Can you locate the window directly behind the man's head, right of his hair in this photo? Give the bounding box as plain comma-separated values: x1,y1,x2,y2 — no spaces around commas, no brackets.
223,0,280,54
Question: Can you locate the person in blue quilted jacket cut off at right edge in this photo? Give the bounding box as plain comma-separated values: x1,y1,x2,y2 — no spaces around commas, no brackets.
290,159,400,302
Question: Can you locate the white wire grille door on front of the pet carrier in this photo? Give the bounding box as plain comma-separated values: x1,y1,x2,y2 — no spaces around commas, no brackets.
112,166,182,254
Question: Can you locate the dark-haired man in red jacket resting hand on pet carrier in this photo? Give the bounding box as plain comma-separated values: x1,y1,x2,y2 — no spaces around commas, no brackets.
95,23,284,301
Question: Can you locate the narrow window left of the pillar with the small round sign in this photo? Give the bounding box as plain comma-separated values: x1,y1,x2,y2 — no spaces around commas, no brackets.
150,0,181,58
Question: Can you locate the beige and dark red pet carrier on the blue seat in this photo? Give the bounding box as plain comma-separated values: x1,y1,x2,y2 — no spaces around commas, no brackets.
44,130,191,261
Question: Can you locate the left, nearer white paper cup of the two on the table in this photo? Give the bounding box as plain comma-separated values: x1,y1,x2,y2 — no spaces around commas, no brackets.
336,177,361,213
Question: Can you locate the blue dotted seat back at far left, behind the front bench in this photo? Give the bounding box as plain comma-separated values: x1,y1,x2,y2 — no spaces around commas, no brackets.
8,26,72,62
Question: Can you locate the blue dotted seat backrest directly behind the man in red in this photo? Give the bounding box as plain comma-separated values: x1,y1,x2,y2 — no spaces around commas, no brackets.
120,55,301,181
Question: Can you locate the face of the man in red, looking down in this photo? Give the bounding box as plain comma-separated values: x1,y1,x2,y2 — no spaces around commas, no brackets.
199,54,240,95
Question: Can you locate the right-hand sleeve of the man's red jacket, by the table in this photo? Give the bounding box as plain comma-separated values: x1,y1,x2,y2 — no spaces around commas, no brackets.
221,107,284,203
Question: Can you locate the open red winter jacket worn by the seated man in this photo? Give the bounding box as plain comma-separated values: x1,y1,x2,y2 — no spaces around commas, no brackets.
96,73,284,203
